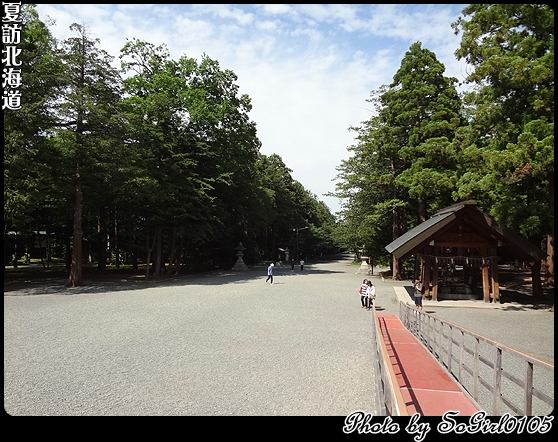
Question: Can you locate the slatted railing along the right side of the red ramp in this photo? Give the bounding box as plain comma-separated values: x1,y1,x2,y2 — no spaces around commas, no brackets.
399,301,554,416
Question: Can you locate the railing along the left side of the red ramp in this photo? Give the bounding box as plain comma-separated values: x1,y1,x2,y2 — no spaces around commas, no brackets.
372,298,409,416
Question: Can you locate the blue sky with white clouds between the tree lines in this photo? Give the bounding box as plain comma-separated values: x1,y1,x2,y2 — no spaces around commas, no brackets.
37,4,468,213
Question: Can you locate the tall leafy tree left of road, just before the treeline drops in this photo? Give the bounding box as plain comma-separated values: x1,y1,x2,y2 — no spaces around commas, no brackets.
191,55,261,260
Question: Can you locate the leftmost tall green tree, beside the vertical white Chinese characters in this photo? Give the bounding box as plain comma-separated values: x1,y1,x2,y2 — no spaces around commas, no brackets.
3,4,62,238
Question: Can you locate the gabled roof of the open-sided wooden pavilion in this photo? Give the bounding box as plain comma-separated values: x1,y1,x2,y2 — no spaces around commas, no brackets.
385,200,546,262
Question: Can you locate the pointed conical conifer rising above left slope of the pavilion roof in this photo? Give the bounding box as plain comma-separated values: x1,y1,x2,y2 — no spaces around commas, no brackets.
380,42,462,222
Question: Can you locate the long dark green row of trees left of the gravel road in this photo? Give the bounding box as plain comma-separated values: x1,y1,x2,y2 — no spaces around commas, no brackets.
4,5,336,286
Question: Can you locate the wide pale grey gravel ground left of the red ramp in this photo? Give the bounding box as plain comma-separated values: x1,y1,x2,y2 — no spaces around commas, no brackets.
4,258,380,416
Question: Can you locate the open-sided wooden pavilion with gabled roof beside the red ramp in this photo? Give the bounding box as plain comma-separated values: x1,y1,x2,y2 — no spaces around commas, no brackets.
385,200,546,302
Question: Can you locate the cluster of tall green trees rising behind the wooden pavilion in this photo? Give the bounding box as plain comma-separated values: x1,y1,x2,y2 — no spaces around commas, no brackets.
333,5,554,280
